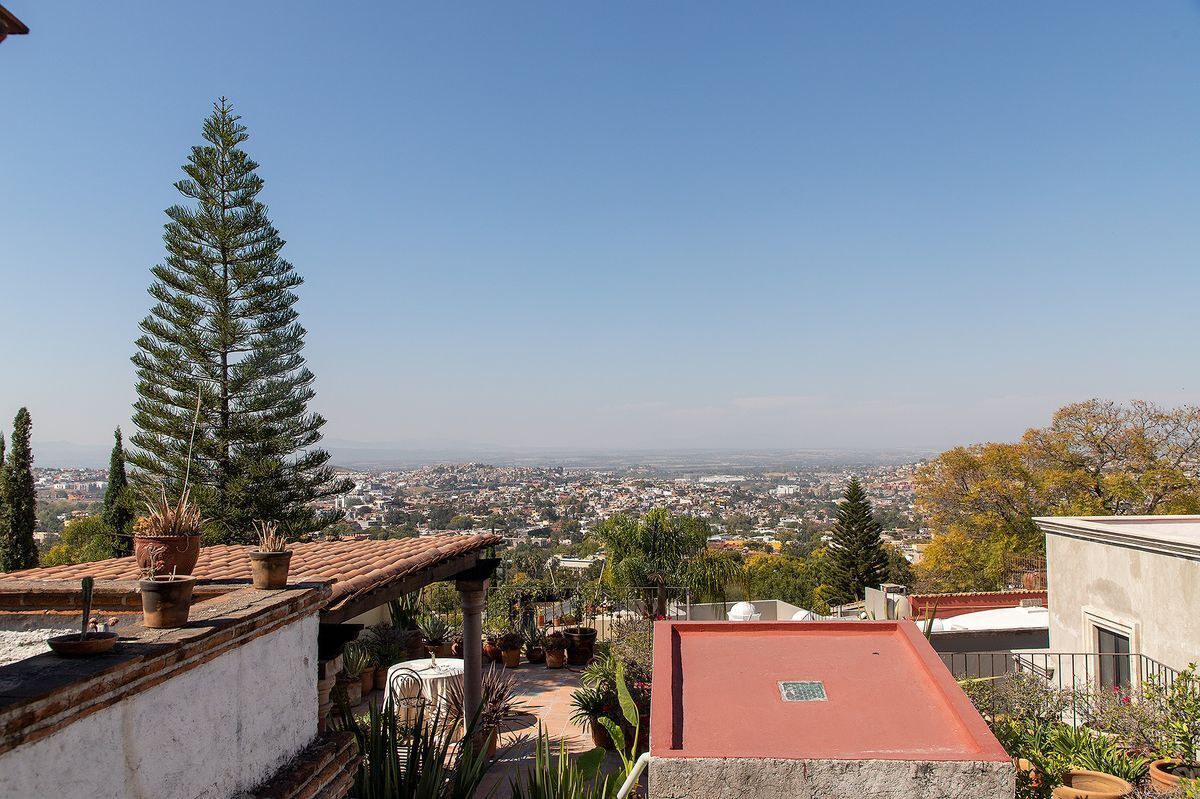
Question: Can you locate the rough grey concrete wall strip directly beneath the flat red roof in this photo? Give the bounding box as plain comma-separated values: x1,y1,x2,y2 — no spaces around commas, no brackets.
649,757,1016,799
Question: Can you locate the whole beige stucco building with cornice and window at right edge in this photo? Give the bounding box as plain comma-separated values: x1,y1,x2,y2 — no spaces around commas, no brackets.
1034,516,1200,685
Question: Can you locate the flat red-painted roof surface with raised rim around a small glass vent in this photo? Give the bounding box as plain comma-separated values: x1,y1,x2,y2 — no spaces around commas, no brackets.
650,621,1009,761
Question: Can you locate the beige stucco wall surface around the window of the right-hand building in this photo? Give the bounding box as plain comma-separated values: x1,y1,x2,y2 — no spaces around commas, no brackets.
1046,535,1200,668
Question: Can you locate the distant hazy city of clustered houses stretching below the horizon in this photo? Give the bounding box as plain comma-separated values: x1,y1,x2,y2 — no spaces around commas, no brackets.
35,451,929,564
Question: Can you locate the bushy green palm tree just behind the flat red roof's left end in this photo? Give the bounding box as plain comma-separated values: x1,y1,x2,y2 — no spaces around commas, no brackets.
596,507,740,615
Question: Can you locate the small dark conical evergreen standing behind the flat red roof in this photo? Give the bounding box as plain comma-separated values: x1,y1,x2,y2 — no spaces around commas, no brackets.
828,477,888,603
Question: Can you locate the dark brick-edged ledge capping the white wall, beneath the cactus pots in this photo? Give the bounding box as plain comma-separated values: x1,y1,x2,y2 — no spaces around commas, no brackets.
0,583,330,753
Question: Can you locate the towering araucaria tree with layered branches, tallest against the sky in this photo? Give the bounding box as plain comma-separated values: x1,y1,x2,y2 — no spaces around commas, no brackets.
130,97,350,542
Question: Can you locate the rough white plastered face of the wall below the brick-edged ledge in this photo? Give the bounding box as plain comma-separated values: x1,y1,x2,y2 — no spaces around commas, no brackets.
0,615,317,799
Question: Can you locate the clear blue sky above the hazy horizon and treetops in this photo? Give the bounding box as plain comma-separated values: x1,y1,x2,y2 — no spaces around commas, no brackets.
0,0,1200,449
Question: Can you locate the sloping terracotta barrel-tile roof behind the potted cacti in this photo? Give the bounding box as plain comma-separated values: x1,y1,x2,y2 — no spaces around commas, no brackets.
0,533,504,607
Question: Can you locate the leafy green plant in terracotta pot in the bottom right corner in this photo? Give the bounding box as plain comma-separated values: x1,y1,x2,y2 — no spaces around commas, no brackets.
1141,663,1200,793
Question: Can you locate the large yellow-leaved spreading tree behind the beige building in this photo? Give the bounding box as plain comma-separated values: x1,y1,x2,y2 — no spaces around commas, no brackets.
916,400,1200,591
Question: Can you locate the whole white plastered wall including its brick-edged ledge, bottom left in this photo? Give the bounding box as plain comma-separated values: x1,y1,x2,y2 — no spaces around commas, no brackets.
0,585,329,799
